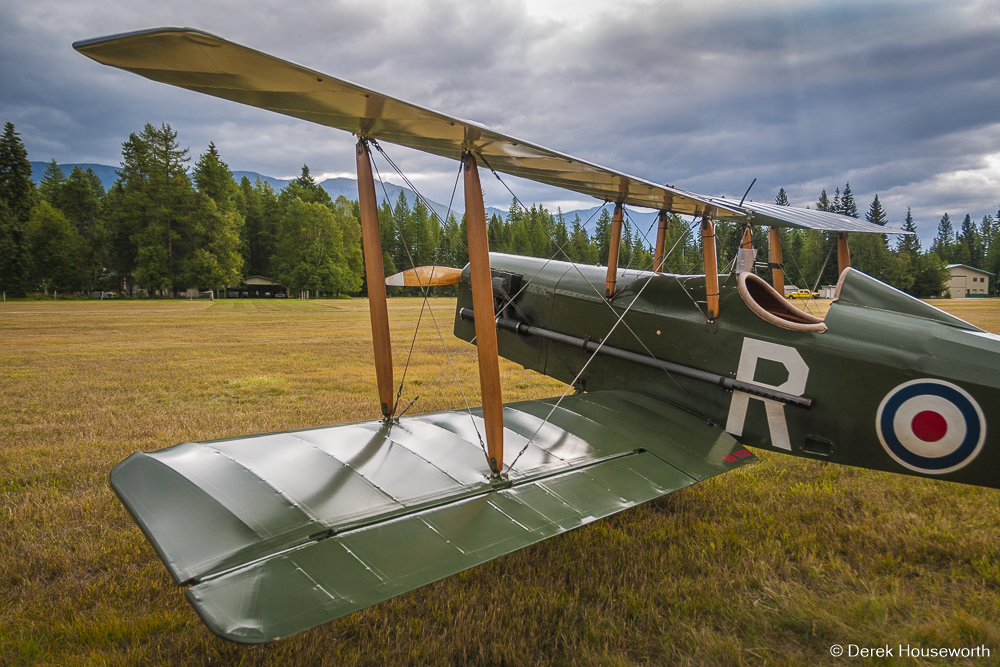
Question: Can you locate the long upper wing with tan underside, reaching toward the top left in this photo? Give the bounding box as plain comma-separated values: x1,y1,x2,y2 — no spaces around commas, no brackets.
73,28,742,217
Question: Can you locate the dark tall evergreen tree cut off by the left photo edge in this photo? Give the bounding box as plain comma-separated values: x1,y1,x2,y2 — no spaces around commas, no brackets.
0,122,35,296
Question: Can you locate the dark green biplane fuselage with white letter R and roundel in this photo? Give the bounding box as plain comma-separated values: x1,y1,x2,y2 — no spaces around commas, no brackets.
455,254,1000,487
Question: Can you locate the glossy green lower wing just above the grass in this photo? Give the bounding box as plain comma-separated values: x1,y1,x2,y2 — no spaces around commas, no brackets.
111,391,754,643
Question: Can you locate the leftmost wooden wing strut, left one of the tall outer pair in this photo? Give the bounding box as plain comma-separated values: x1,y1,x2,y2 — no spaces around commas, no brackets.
357,139,395,419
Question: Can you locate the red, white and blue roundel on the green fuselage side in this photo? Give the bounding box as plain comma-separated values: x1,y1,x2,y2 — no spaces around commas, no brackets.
875,380,986,475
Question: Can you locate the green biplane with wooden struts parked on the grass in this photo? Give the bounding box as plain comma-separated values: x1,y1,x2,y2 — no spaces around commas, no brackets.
74,28,1000,643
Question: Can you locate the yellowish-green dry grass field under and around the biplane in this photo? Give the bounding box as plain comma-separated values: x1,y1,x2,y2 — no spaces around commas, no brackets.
0,299,1000,665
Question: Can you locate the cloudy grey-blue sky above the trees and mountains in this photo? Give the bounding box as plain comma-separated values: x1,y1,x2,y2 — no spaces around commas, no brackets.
0,0,1000,245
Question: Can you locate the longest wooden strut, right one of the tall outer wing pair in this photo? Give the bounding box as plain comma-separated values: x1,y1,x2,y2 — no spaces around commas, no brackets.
463,153,503,477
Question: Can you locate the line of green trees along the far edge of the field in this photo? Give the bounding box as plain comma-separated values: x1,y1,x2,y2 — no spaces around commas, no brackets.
0,122,1000,297
